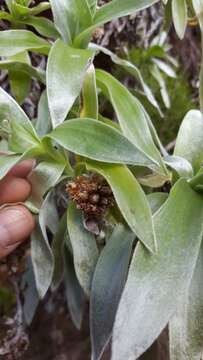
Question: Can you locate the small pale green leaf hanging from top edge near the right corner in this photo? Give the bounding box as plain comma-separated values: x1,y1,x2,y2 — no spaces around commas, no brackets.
172,0,188,39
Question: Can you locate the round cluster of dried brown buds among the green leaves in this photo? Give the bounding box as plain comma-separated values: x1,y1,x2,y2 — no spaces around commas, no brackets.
66,174,115,217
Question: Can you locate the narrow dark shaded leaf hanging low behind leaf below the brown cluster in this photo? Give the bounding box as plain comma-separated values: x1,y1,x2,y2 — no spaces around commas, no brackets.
64,247,85,330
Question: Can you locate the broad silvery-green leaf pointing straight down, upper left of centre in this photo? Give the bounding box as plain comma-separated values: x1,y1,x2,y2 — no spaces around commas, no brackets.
47,40,93,127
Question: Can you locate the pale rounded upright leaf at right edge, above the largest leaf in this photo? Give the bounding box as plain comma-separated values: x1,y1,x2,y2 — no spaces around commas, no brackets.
174,110,203,172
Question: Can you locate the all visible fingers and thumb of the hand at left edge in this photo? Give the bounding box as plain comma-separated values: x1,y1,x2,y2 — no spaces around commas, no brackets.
0,160,35,259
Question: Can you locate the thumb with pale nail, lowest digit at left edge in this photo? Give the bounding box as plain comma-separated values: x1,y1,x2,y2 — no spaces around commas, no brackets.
0,205,34,258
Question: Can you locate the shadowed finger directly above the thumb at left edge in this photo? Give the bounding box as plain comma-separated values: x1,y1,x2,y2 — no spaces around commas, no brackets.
0,176,31,205
